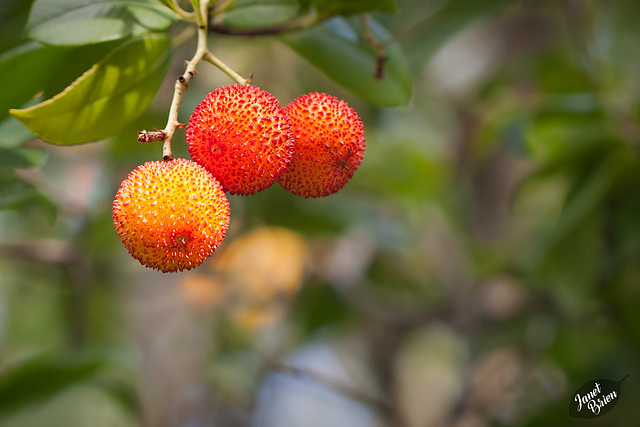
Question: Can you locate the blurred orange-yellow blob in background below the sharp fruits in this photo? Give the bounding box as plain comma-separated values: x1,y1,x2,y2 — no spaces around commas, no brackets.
181,227,308,330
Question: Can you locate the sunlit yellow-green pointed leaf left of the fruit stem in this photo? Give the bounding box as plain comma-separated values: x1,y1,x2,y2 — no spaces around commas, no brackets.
10,34,171,145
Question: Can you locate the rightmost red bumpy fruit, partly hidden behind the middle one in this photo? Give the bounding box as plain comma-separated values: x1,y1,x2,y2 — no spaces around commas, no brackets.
278,93,365,197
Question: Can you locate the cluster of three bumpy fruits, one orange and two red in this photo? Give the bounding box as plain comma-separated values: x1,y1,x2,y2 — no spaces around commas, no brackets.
113,84,365,272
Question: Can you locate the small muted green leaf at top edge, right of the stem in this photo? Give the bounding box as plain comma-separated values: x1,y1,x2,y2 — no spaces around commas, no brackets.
222,0,300,28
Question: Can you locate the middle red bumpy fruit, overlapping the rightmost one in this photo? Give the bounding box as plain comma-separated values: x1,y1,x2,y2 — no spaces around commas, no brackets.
187,84,293,195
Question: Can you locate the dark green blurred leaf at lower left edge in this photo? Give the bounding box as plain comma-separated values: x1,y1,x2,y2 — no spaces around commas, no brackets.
0,356,102,417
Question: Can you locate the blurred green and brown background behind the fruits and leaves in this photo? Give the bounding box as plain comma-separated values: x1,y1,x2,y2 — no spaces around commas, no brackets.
0,0,640,427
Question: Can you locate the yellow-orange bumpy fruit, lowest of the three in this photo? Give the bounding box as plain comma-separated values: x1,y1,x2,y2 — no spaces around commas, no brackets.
113,159,229,273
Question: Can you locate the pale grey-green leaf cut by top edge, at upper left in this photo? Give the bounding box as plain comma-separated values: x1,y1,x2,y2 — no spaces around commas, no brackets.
27,0,178,46
